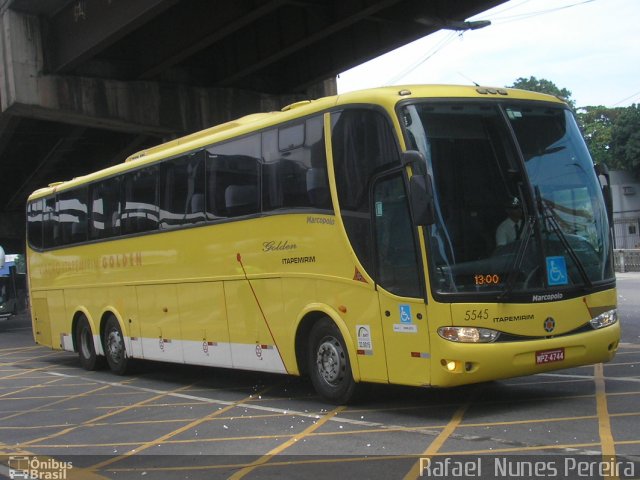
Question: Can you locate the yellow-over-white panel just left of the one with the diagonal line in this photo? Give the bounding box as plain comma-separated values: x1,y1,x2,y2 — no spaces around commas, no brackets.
178,282,232,367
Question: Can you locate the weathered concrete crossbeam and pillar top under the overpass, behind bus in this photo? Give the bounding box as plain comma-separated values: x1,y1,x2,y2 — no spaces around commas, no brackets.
0,9,310,138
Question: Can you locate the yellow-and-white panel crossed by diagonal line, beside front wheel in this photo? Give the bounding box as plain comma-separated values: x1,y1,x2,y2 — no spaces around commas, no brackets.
224,279,287,373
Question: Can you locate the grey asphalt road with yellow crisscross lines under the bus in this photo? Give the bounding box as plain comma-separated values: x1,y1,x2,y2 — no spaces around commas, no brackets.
0,273,640,479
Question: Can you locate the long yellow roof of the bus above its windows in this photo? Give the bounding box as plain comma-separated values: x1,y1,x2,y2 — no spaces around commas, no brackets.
29,85,565,199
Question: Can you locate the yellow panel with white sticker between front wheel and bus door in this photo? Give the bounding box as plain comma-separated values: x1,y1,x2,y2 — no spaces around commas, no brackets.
317,280,388,383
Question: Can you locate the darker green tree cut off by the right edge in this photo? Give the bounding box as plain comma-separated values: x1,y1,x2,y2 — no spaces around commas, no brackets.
611,104,640,178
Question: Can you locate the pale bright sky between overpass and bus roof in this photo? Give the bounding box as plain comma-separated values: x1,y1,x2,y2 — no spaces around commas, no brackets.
337,0,640,107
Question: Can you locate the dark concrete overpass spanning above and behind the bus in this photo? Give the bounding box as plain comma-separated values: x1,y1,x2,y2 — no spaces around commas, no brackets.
0,0,505,251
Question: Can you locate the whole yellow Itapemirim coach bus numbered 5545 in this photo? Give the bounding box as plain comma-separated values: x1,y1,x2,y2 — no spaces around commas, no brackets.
26,86,620,403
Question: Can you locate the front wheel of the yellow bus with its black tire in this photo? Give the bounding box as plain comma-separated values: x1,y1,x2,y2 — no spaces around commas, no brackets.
308,318,358,405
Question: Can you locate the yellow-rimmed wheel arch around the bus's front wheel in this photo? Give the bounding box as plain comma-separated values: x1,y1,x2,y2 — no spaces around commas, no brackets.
294,303,360,382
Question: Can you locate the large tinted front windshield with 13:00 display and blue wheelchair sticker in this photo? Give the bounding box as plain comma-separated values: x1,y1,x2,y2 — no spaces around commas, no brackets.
400,101,615,301
